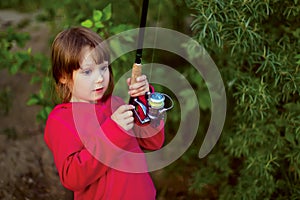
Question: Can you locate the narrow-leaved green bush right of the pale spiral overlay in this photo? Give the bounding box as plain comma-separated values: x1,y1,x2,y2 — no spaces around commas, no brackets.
186,0,300,199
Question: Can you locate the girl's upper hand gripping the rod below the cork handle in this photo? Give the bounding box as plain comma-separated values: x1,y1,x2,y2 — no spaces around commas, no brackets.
127,75,149,97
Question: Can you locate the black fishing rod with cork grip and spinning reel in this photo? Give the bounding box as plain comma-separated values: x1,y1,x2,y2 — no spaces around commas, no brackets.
129,0,174,126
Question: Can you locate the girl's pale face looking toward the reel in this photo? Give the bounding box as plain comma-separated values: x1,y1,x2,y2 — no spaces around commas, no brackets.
70,47,110,103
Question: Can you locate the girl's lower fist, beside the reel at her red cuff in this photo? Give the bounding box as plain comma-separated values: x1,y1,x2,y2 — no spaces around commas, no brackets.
111,105,134,131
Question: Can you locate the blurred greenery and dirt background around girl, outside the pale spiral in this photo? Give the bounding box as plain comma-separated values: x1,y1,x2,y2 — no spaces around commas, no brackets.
0,0,300,200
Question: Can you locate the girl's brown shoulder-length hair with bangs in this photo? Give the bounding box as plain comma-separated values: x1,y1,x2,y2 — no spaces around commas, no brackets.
51,27,114,103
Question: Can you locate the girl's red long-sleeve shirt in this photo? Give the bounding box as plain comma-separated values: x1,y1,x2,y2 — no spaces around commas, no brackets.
44,96,164,200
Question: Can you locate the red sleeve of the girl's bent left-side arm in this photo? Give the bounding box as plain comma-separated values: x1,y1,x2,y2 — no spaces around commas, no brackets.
45,111,130,191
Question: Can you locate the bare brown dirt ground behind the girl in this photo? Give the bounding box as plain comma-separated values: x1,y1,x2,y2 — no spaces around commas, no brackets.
0,10,202,200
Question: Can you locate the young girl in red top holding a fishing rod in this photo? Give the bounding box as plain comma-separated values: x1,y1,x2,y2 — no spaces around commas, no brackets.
44,27,164,200
